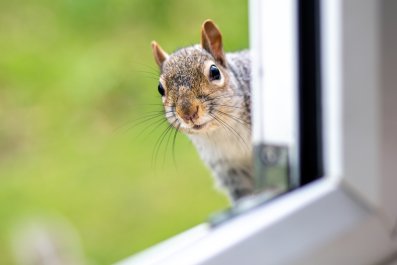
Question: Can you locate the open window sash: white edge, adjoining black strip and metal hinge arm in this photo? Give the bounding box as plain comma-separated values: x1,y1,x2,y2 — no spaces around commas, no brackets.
209,0,323,224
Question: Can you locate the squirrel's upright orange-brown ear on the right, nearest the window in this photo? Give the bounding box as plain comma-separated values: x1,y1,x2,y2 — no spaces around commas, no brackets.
201,19,225,66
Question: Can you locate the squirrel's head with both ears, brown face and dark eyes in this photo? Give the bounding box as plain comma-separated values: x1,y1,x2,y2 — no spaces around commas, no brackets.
148,20,234,134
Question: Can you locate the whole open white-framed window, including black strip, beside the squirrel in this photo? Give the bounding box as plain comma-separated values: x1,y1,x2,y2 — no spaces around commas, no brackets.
116,0,397,265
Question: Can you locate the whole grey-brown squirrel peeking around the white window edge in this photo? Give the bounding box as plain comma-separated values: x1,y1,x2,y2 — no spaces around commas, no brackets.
151,20,254,203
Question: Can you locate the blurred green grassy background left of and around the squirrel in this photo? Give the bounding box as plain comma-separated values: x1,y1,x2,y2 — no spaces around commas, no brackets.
0,0,248,264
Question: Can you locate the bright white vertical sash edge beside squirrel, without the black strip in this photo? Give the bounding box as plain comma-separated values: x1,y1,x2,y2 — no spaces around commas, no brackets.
251,1,299,198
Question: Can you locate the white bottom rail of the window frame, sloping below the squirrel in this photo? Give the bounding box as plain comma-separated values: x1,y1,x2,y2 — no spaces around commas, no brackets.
118,176,397,265
